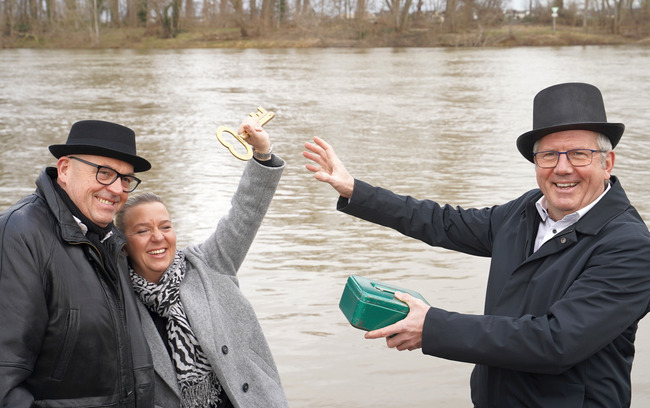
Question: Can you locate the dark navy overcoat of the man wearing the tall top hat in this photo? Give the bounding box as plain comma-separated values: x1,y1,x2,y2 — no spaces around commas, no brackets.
338,177,650,408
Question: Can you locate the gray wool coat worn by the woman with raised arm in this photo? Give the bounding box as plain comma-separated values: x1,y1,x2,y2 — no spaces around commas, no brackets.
138,156,288,408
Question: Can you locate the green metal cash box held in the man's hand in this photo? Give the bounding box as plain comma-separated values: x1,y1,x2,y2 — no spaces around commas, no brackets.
339,275,429,331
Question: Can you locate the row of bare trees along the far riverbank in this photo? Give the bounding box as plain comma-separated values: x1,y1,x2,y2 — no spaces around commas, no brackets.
0,0,650,41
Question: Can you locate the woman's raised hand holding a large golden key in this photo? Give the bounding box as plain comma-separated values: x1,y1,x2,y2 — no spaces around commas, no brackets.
217,107,275,160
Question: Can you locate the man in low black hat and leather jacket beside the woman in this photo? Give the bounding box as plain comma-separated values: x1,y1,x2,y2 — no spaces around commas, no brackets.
0,120,153,407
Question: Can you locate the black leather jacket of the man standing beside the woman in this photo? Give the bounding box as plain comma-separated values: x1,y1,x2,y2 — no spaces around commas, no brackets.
0,168,153,407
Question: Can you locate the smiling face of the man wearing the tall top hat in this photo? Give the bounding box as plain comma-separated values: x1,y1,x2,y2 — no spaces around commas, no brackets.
535,130,614,221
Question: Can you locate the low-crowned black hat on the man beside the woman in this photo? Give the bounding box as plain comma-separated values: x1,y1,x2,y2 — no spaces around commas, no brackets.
49,120,151,172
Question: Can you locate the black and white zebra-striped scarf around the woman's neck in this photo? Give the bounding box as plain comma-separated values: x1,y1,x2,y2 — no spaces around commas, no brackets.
129,251,222,408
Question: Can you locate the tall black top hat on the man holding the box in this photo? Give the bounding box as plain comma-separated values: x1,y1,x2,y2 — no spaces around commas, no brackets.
517,82,625,162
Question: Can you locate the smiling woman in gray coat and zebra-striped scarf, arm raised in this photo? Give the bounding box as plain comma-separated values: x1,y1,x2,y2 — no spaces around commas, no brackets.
116,118,288,408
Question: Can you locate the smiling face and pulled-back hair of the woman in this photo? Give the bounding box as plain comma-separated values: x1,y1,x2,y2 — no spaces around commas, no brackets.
123,202,176,283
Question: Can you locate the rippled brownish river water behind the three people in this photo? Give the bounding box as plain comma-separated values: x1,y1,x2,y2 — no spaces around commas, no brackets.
0,46,650,408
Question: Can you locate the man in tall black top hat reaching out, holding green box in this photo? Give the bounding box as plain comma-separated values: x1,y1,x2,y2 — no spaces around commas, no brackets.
304,83,650,408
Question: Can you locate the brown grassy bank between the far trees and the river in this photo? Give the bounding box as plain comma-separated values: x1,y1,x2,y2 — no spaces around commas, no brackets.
5,23,650,49
